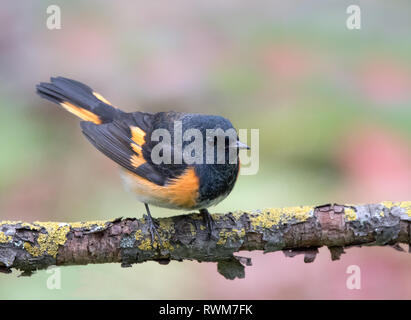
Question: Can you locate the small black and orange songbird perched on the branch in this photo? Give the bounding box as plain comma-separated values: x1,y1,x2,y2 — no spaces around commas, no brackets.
37,77,249,242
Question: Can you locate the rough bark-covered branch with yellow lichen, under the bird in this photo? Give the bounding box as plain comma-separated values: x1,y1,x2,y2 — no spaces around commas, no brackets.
0,201,411,279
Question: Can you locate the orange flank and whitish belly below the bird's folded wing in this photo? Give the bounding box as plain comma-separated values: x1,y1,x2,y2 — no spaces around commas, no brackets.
125,167,200,209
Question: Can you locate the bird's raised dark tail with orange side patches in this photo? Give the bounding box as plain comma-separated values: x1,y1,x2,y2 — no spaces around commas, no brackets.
36,77,121,124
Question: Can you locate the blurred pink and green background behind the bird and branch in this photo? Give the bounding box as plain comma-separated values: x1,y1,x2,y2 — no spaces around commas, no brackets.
0,0,411,299
